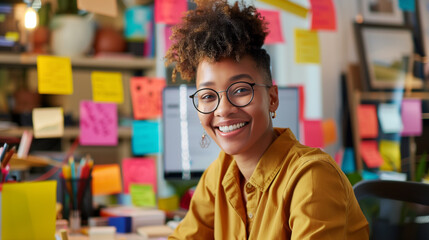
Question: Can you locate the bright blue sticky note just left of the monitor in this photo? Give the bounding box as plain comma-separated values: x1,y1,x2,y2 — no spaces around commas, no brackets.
131,121,160,155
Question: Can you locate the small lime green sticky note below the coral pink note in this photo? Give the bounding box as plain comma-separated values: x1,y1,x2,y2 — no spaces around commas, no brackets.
130,184,156,207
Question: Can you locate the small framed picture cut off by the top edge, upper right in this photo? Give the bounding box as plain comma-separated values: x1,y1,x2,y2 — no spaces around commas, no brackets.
359,0,404,24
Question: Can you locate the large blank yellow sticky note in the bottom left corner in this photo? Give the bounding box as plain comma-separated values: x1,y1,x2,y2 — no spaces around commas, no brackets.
1,181,57,240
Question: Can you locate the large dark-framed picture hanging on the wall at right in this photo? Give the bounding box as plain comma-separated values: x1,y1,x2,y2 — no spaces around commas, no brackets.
355,23,423,91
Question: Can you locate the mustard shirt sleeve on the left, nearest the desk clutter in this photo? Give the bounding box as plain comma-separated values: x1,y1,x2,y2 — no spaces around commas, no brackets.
168,169,214,240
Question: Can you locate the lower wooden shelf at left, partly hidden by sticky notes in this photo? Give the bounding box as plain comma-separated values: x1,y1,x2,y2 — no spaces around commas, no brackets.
0,127,131,139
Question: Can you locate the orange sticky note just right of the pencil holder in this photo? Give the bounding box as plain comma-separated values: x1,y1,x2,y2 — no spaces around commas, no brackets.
92,164,122,195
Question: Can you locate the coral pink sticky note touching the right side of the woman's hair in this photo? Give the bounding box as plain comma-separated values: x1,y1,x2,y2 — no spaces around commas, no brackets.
258,9,284,44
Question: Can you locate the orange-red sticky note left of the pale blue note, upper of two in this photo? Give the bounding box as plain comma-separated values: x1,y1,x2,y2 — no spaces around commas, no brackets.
357,104,378,138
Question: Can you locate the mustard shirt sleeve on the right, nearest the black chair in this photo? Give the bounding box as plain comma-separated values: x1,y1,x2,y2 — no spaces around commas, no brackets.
289,155,368,240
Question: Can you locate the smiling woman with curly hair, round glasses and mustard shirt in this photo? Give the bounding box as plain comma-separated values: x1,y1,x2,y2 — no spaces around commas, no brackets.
166,0,368,240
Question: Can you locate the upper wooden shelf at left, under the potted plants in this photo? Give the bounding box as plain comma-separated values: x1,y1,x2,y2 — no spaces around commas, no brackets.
0,53,156,70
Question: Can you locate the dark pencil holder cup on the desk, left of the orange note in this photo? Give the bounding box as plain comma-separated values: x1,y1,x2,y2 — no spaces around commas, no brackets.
60,178,92,225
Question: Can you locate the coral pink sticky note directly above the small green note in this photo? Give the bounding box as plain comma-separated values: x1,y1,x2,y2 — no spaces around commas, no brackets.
122,158,157,193
